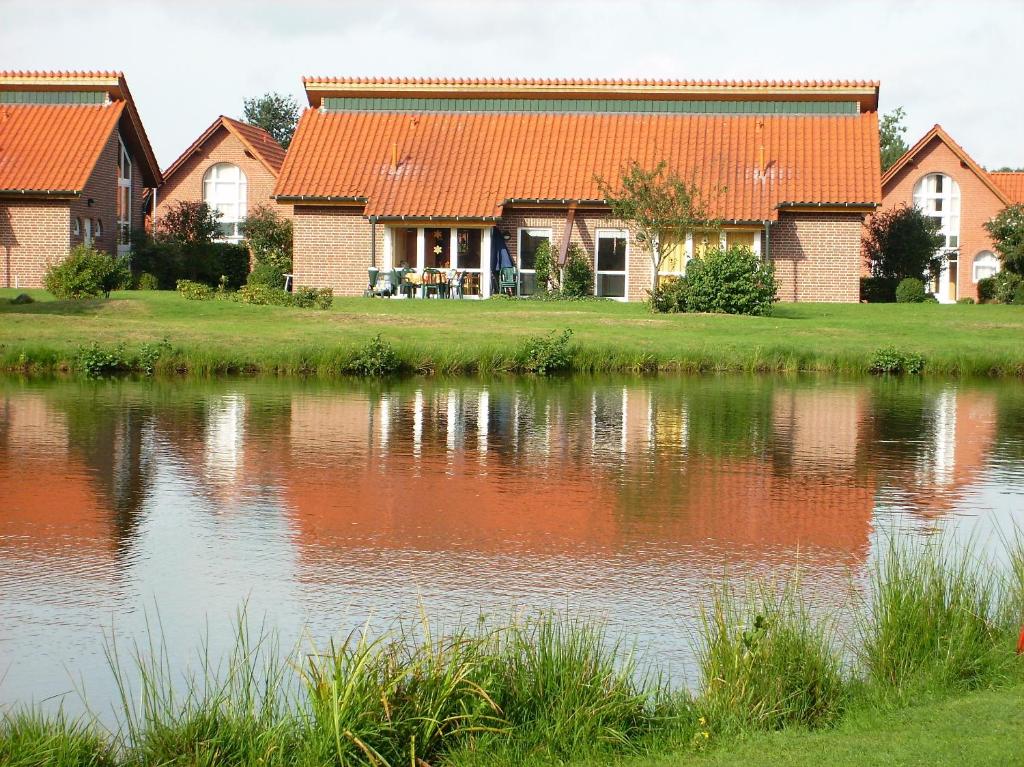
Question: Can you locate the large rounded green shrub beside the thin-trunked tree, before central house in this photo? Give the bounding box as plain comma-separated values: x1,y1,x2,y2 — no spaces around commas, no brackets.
686,247,778,315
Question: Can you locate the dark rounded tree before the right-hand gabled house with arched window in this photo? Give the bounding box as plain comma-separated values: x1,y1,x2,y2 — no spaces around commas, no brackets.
861,205,946,280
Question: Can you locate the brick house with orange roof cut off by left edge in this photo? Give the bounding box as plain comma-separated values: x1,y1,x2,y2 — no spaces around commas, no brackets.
0,72,160,288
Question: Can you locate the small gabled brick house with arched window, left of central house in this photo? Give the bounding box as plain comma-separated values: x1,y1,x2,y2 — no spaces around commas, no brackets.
157,115,292,243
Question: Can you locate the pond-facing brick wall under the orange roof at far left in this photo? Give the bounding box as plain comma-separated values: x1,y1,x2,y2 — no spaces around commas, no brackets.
0,200,71,288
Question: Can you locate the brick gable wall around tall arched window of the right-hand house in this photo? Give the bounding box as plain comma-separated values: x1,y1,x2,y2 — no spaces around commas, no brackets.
882,137,1002,298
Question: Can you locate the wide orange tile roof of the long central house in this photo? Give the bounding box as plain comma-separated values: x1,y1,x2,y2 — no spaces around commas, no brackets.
274,110,881,221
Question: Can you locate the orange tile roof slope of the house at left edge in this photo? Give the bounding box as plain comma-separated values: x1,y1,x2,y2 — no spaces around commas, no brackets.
0,101,125,193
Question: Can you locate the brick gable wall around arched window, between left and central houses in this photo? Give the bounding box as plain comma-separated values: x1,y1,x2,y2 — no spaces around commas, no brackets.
157,127,292,223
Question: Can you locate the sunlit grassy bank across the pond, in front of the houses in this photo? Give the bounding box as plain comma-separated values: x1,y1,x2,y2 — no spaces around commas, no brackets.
6,290,1024,376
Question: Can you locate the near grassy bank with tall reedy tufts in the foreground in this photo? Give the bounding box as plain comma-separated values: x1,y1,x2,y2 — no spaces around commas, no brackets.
6,539,1024,767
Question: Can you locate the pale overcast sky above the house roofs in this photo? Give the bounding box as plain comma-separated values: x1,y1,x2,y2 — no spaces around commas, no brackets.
6,0,1024,168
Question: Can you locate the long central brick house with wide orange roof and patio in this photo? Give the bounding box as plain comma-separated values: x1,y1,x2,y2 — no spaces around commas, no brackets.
274,78,881,301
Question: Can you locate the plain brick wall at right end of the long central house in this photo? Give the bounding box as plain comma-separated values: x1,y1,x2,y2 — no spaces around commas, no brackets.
762,213,863,302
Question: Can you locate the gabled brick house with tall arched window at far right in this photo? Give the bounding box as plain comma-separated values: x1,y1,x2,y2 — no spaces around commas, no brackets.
882,125,1024,303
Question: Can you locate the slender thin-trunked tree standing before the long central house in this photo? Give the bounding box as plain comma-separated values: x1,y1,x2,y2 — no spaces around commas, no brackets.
596,160,718,291
